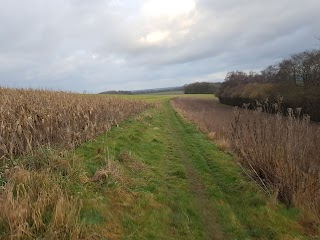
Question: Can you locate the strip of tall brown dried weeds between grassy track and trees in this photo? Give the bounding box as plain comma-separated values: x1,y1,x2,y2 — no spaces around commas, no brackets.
172,98,320,223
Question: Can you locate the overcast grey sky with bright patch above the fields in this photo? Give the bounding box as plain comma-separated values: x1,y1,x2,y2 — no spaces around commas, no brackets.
0,0,320,93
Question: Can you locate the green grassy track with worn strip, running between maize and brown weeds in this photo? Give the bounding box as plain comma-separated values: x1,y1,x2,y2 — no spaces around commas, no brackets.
76,96,310,240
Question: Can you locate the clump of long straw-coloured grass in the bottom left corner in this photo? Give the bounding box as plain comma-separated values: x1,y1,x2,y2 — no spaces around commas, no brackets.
0,166,84,239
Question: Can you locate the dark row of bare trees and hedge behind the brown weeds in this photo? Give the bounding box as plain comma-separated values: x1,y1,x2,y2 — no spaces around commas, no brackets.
217,50,320,121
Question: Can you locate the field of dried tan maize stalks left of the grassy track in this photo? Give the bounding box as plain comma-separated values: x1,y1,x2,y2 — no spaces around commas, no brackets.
0,88,150,158
